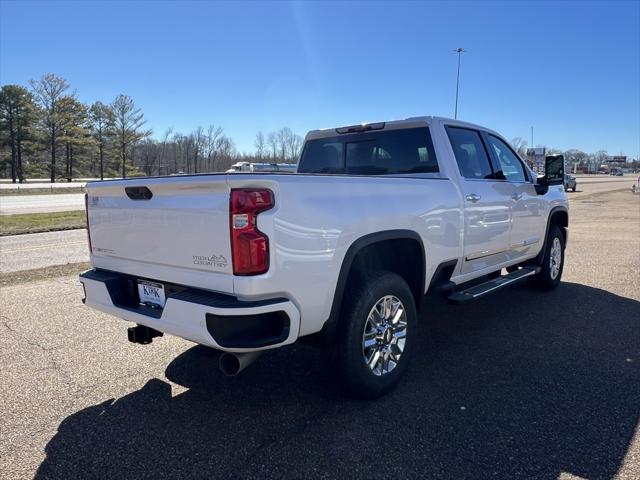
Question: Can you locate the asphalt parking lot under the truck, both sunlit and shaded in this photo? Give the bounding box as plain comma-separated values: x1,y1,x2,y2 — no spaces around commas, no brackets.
0,186,640,479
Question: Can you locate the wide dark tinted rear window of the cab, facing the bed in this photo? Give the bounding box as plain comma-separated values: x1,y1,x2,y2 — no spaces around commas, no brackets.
298,127,439,175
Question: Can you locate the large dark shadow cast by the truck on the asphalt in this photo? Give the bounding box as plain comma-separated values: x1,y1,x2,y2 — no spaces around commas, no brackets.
36,283,640,479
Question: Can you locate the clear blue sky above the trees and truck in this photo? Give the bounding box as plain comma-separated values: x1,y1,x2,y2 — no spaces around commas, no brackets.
0,0,640,156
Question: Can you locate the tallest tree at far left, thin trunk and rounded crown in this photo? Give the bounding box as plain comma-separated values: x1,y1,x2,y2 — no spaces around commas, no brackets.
29,73,75,183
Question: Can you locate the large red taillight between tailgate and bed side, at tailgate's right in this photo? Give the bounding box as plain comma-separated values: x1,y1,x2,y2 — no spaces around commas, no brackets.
229,188,274,275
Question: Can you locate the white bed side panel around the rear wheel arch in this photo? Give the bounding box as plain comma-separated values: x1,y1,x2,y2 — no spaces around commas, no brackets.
229,175,461,335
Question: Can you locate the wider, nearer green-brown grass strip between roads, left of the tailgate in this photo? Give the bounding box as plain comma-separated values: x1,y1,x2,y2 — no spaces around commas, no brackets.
0,210,86,236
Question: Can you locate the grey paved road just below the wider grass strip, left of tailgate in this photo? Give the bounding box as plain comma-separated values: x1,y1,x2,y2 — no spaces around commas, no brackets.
0,229,89,273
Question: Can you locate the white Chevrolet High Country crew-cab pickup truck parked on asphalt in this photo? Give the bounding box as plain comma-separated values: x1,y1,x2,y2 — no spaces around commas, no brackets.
80,117,569,398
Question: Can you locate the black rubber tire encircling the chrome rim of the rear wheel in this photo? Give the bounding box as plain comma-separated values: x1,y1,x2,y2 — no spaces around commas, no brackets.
329,270,418,399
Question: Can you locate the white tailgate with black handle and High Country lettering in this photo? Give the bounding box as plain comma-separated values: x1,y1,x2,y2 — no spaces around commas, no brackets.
87,175,233,293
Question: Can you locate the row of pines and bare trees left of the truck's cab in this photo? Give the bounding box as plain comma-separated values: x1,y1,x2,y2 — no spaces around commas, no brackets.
0,74,303,183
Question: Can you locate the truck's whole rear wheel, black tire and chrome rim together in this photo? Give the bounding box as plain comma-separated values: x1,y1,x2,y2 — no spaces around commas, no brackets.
331,271,417,398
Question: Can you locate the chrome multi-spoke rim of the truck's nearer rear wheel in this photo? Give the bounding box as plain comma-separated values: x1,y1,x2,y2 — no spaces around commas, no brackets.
362,295,407,376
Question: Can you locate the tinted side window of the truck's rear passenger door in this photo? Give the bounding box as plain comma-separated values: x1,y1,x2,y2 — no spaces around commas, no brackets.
446,127,493,179
